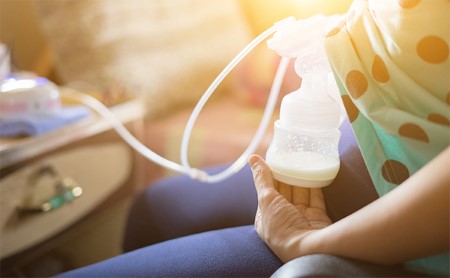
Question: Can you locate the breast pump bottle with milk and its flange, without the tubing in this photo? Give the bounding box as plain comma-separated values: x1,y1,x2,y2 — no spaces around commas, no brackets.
266,16,340,188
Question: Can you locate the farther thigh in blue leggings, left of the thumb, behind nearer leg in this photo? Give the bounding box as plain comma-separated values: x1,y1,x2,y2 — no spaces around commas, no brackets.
123,166,257,251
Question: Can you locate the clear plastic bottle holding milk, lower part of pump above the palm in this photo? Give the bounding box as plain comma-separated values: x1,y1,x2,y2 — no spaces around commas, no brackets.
266,81,340,187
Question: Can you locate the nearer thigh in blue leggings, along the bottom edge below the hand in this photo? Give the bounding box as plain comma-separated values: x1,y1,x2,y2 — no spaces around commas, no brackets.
62,225,282,277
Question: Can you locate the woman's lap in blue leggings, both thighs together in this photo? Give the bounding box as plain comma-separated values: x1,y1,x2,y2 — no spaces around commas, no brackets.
58,118,377,277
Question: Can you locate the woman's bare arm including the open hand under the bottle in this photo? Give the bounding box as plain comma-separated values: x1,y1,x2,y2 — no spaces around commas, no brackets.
249,147,450,264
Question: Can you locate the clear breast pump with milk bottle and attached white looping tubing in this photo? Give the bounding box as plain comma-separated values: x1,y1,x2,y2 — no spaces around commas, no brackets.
0,15,340,187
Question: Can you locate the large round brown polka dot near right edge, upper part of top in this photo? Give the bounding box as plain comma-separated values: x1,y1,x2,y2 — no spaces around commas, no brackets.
416,36,449,64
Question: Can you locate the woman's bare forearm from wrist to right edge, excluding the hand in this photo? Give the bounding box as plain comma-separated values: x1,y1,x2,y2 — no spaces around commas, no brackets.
307,148,450,264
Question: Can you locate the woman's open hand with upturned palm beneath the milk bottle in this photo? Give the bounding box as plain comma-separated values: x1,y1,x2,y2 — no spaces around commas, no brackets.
249,155,331,262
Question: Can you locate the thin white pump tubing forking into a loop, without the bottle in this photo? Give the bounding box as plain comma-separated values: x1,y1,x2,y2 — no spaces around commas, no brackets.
63,21,289,183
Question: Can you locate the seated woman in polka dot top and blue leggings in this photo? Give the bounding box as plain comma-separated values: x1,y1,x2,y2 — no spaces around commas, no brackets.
63,0,450,277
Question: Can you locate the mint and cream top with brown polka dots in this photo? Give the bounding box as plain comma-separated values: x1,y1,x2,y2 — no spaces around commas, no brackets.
325,0,450,275
